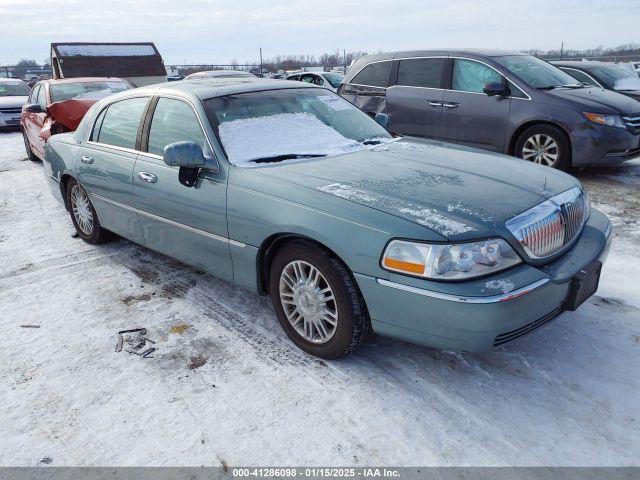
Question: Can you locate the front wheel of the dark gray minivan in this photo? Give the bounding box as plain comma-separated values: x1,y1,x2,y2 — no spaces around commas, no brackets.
514,125,571,170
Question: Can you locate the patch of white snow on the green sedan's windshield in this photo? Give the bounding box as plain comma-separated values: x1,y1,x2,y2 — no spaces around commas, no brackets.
218,113,361,165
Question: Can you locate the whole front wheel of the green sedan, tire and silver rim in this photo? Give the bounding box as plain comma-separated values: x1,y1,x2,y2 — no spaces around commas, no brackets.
269,240,371,359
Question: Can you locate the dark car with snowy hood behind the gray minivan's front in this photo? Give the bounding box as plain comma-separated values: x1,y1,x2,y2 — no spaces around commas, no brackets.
551,61,640,100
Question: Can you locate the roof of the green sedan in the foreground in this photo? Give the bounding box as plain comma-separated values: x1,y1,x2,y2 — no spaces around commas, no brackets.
128,77,322,100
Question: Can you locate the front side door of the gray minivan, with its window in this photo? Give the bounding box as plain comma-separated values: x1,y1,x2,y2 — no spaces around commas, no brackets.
442,58,511,152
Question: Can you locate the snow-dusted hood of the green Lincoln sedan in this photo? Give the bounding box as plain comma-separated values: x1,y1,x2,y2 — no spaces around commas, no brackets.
256,138,579,240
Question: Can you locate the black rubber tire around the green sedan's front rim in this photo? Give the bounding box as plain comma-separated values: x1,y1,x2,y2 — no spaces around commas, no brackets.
269,240,372,359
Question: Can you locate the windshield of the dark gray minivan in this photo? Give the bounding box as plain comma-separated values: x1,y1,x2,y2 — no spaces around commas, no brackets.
494,55,577,88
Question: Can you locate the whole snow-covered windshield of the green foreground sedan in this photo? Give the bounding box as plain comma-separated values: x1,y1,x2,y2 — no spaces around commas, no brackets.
204,88,392,165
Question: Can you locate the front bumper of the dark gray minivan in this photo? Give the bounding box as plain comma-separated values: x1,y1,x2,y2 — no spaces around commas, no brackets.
571,125,640,167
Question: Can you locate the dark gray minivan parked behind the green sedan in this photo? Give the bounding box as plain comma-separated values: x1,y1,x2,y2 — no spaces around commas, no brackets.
338,50,640,169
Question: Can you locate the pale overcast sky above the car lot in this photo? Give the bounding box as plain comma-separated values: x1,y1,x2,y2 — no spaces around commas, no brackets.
0,0,640,65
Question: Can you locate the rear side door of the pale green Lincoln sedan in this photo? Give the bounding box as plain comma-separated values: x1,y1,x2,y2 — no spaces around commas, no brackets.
76,97,150,243
